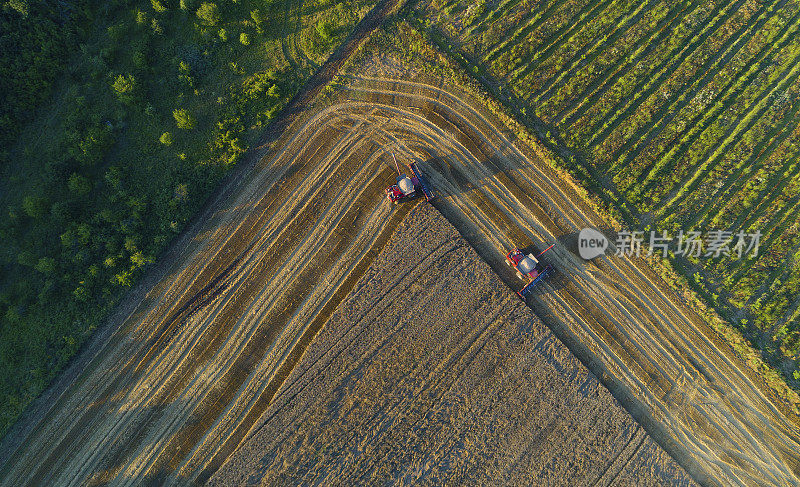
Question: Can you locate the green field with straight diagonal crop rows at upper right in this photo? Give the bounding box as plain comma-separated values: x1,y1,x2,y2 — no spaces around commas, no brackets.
410,0,800,388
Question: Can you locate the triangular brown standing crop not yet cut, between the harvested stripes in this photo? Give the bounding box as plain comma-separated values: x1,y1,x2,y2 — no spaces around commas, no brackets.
210,203,696,486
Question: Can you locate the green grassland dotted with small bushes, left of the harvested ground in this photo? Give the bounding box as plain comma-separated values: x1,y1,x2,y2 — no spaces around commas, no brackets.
0,0,370,434
